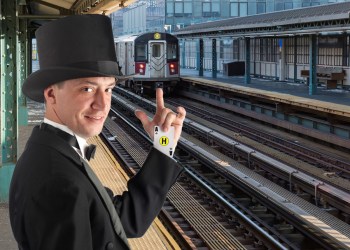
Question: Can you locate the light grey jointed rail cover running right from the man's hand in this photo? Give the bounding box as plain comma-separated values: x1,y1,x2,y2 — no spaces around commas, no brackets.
113,86,350,223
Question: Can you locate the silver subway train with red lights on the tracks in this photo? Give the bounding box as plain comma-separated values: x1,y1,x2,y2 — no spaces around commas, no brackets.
115,32,180,94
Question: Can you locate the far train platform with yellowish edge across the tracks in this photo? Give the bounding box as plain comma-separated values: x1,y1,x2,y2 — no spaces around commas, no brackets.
181,68,350,114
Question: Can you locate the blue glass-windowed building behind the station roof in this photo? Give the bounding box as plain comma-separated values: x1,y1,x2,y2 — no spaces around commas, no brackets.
111,0,346,36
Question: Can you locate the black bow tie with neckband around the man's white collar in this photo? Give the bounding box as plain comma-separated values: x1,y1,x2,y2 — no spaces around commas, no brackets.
40,123,96,161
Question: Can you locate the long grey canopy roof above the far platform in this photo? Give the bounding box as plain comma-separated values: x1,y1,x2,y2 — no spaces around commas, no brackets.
174,2,350,38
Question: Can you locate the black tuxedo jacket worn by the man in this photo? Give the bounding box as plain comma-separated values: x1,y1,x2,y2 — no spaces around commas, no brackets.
9,126,182,250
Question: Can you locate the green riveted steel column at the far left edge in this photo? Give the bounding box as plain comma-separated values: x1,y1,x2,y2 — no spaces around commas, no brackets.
0,1,18,202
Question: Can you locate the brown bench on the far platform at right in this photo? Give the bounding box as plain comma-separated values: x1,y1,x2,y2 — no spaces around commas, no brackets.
300,66,345,89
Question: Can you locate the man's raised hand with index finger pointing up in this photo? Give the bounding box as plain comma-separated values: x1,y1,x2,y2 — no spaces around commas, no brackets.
135,88,186,147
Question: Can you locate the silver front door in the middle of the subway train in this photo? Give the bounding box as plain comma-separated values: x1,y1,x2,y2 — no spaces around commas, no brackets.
148,41,166,78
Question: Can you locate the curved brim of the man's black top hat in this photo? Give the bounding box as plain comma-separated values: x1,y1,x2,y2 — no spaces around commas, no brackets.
22,67,132,103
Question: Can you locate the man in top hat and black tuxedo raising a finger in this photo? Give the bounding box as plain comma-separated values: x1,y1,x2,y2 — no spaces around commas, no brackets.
10,15,186,250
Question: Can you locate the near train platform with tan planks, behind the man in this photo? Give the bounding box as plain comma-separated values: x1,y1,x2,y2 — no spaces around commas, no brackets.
0,105,180,250
